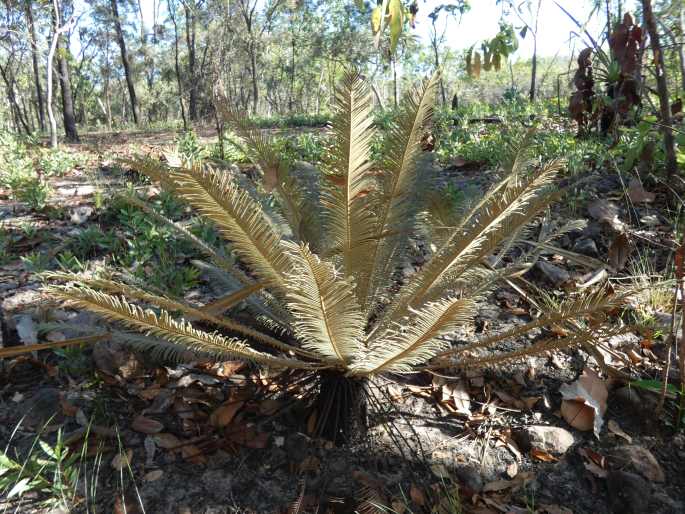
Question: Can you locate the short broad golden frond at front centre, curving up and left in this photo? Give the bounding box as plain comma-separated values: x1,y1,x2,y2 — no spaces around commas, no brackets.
286,243,365,365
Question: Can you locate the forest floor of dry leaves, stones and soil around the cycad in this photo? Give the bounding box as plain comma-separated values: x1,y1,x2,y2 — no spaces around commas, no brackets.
0,127,685,514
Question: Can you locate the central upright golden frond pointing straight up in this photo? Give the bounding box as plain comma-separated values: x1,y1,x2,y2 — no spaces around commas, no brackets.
321,70,376,288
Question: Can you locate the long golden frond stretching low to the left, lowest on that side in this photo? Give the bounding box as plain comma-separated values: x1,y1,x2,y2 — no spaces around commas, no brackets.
46,286,315,369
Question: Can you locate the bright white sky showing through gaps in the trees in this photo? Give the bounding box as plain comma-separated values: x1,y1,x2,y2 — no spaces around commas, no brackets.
72,0,635,59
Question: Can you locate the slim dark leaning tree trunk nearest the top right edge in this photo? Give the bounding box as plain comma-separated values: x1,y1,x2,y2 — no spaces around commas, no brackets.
642,0,678,177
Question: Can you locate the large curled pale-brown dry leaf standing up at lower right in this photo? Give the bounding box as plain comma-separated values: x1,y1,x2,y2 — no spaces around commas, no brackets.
559,368,609,437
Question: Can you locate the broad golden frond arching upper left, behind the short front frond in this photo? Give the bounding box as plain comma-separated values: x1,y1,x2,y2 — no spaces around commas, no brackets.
171,164,290,293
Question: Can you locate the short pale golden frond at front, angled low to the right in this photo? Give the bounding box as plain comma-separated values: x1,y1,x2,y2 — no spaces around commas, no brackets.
353,298,475,375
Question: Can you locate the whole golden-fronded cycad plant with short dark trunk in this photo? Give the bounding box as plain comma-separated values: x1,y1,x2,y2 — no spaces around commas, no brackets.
48,71,616,440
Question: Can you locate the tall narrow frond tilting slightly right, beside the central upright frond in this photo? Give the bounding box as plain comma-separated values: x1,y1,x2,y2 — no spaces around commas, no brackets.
357,72,439,307
